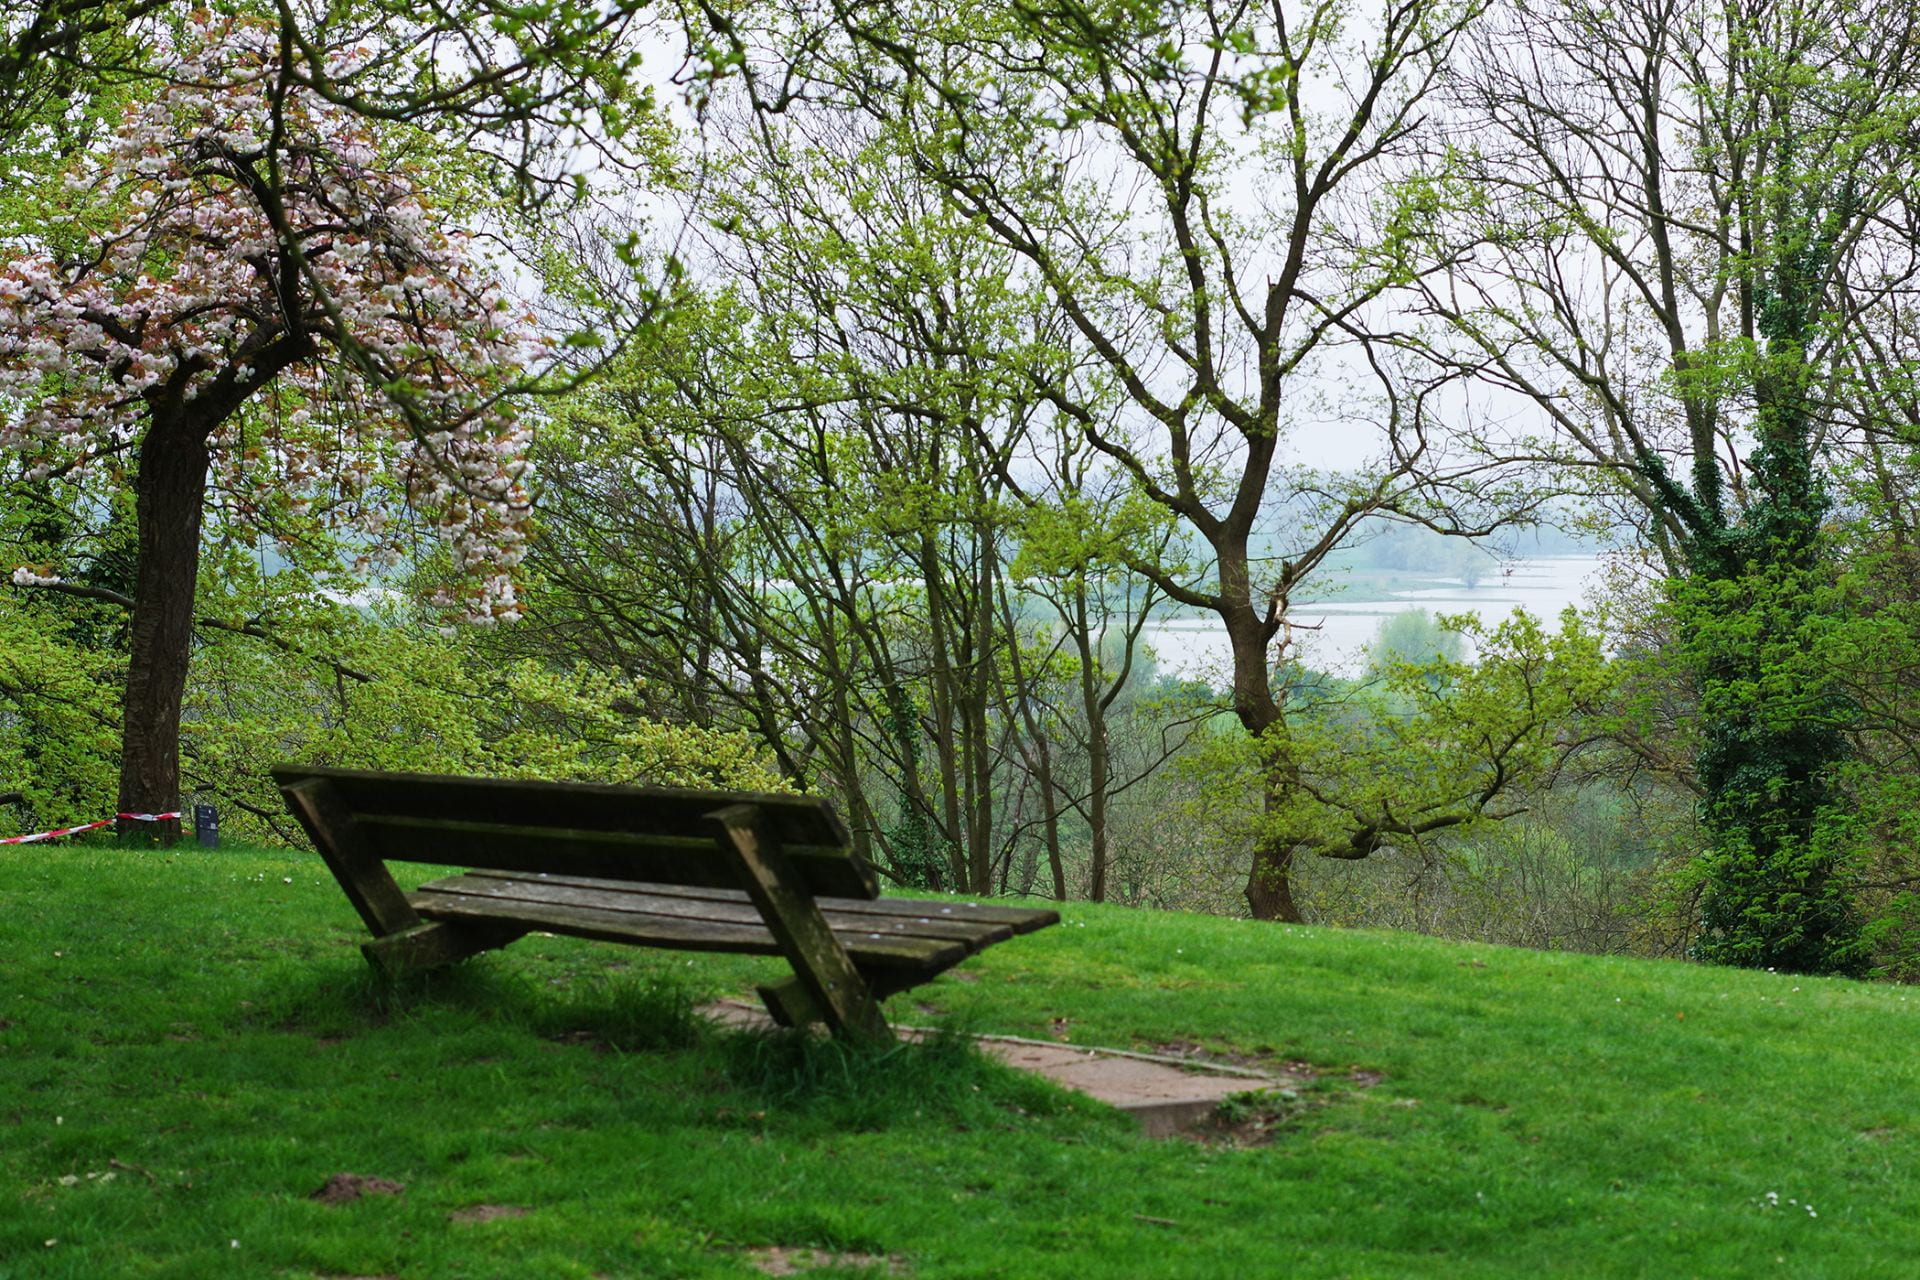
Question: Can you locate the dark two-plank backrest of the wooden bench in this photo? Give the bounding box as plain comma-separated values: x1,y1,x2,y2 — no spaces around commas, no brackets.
273,764,879,898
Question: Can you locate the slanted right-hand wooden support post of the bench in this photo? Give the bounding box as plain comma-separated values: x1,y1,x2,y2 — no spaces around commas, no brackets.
707,804,890,1040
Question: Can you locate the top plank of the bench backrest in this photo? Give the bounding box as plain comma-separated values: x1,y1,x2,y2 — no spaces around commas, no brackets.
273,766,851,848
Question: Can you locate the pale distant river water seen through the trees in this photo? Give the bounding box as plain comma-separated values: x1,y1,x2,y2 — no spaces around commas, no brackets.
1144,555,1601,683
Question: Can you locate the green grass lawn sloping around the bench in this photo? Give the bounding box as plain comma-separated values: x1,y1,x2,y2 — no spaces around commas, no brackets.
0,846,1920,1280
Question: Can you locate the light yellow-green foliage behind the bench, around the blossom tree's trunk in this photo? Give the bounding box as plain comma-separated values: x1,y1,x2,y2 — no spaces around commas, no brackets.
0,545,785,839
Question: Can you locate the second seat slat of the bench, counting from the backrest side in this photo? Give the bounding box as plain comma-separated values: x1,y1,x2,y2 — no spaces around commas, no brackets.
420,873,1014,952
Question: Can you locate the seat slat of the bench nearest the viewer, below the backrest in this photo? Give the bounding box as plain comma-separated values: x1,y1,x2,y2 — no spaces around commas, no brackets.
409,892,972,973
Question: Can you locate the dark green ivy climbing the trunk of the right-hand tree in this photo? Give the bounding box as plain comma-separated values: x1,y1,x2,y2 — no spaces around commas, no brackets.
1672,70,1878,973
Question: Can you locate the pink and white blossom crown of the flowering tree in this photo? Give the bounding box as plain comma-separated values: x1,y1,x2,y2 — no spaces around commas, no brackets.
0,13,541,620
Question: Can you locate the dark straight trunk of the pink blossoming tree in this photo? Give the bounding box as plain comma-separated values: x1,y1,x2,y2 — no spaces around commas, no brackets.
119,422,207,844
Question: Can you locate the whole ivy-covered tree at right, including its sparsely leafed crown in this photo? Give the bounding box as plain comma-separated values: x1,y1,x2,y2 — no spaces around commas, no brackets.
1425,0,1920,973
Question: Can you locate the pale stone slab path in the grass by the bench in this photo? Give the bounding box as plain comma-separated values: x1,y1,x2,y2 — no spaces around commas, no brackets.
703,1000,1286,1138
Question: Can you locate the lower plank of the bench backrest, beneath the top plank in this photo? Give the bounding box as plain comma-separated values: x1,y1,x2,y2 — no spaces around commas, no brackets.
359,814,879,898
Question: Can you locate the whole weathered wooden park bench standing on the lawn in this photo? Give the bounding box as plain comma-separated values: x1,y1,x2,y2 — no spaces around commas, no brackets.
273,766,1060,1036
